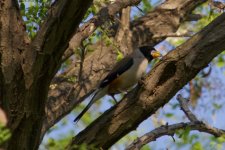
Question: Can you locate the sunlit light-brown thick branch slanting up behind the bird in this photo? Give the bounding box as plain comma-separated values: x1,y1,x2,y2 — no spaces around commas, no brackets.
43,0,208,137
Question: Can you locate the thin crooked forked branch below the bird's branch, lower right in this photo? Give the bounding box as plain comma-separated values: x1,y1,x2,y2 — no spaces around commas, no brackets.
126,94,225,150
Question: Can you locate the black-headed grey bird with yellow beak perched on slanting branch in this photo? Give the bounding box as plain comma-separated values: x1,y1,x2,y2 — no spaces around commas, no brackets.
74,46,161,122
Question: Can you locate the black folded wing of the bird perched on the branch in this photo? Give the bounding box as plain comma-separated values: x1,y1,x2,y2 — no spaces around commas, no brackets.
99,56,134,88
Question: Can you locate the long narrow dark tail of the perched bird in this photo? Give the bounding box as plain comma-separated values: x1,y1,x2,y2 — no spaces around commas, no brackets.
74,88,106,122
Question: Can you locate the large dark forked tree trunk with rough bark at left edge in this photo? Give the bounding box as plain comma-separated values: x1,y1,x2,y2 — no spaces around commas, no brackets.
0,0,92,150
